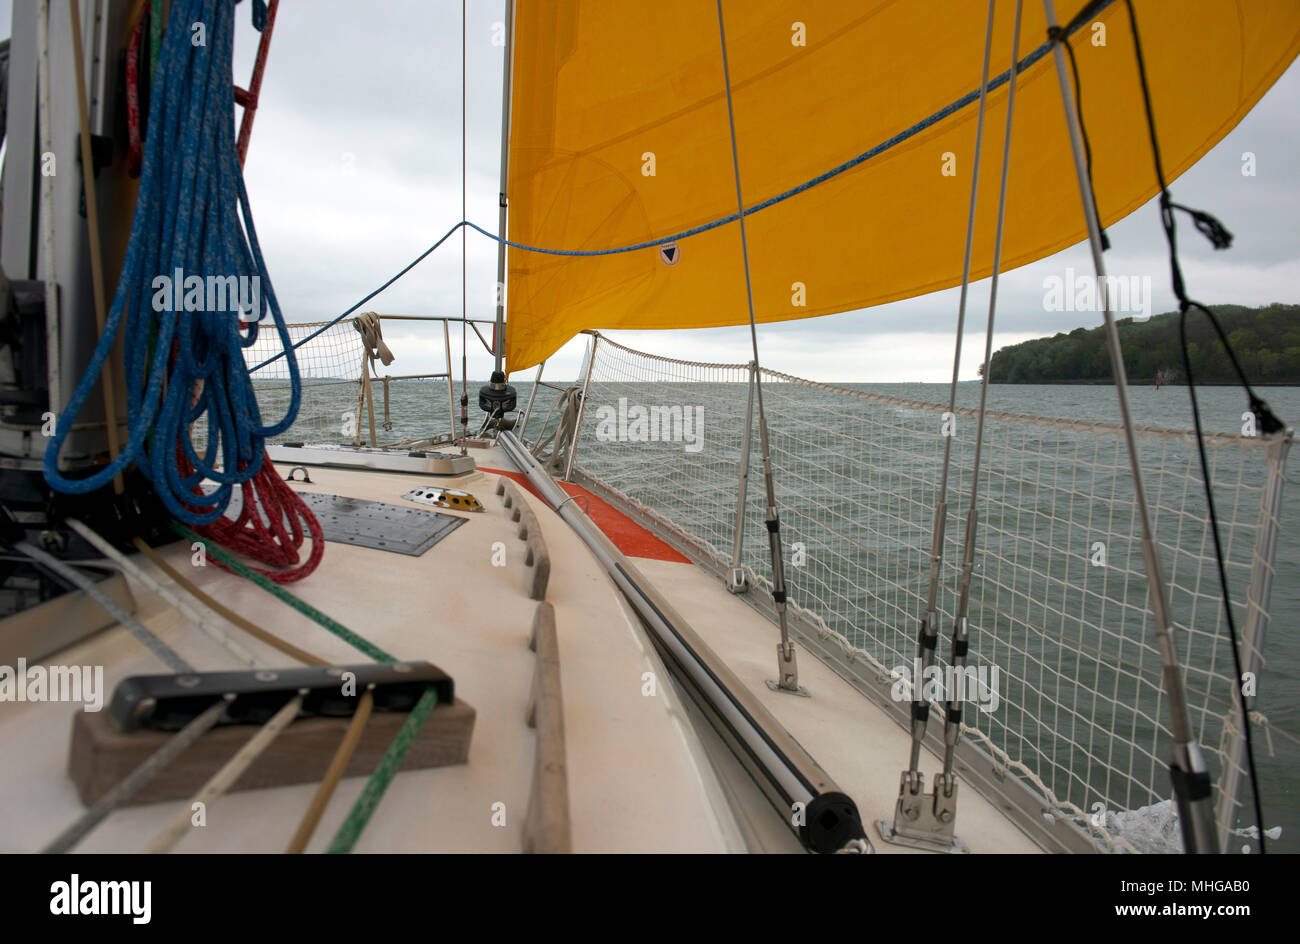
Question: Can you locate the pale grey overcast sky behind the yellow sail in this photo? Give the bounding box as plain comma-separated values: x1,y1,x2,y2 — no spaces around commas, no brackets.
10,0,1300,381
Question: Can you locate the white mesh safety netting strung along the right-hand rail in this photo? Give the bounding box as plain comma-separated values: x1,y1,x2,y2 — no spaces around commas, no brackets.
577,338,1284,848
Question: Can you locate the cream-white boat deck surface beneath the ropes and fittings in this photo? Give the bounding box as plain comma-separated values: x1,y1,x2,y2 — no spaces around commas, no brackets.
0,444,1037,852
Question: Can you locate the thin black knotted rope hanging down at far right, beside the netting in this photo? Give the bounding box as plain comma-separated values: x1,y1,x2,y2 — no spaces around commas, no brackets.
1125,0,1283,854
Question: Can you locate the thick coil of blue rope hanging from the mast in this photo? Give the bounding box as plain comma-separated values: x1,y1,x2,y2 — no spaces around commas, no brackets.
44,0,302,525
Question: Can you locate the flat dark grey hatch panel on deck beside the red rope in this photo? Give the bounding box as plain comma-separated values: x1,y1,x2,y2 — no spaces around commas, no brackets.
298,492,465,558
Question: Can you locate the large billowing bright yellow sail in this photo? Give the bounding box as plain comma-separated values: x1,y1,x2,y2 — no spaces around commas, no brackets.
506,0,1300,371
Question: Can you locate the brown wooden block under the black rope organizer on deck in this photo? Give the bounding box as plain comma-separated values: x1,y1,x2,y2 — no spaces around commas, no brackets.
68,698,476,806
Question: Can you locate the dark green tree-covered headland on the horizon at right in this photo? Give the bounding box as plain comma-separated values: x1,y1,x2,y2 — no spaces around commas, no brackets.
989,303,1300,386
